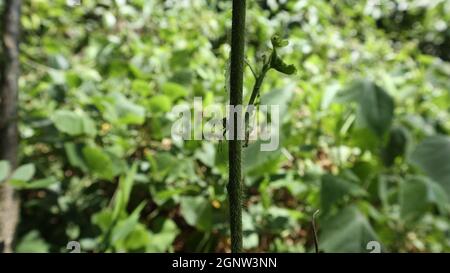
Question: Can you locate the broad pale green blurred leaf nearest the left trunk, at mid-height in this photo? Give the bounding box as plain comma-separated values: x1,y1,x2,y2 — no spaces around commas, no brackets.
52,110,96,136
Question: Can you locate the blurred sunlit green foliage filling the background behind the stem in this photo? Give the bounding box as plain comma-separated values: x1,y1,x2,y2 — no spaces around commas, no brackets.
0,0,450,252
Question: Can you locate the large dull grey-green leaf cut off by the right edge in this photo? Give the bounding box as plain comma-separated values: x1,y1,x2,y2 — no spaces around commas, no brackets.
410,135,450,196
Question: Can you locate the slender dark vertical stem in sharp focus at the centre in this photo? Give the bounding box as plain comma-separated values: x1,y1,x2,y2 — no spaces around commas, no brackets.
228,0,246,253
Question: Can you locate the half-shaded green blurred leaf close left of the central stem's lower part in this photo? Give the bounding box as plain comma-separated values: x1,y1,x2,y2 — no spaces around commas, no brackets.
180,196,213,231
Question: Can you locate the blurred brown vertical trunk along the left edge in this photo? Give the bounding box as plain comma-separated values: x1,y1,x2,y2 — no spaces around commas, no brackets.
0,0,21,252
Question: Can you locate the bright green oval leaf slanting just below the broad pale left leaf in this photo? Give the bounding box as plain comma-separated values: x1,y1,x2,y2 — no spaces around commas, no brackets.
82,146,114,180
